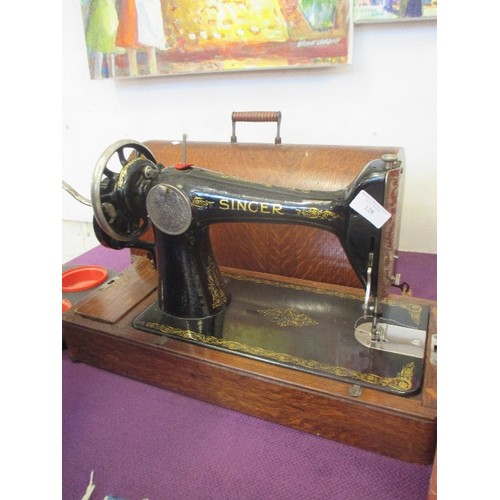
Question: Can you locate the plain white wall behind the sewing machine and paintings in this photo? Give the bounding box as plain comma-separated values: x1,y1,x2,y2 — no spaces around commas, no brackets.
62,1,437,253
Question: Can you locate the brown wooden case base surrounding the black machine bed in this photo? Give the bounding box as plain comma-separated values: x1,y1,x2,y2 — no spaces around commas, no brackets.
63,257,437,464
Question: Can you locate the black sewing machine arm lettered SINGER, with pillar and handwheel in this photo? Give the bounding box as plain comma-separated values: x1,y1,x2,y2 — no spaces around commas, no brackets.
92,141,400,318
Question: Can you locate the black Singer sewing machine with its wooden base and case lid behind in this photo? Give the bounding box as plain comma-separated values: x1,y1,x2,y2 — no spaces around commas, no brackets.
63,114,436,463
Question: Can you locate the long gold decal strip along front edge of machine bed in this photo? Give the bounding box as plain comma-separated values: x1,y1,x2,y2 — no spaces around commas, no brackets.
137,321,415,391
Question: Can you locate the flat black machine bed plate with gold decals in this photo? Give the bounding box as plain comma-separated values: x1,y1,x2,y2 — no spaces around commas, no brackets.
133,273,429,395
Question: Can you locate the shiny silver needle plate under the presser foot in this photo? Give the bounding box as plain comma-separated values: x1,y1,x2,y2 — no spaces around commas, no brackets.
354,321,427,359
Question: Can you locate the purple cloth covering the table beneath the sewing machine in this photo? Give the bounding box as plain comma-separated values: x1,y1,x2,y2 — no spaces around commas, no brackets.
62,247,436,500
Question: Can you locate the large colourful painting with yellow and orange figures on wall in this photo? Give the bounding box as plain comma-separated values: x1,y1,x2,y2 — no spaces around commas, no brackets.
80,0,352,79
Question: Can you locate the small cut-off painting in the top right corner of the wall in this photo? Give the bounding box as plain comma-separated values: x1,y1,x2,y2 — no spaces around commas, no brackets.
353,0,437,23
